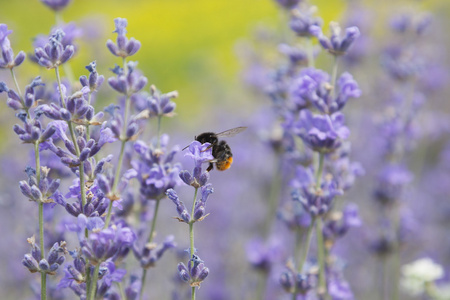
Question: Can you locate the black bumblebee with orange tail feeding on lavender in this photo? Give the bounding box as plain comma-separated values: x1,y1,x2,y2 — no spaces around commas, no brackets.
185,127,247,172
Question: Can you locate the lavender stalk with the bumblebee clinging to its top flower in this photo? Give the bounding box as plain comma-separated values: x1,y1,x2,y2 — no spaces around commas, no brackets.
166,141,214,300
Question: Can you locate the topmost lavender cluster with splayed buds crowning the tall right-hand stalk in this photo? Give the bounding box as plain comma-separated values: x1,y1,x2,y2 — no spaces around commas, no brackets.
315,22,360,56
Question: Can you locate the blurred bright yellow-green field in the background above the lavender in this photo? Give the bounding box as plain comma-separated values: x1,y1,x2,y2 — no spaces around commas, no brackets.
0,0,346,126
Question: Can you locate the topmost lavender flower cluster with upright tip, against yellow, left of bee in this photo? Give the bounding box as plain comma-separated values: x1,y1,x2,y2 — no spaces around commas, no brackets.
106,18,141,57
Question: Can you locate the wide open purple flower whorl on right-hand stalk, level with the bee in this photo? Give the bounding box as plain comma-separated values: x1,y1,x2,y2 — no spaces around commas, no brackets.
295,109,350,153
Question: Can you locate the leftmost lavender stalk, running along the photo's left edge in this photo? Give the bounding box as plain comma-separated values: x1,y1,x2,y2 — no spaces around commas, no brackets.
0,24,64,299
